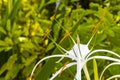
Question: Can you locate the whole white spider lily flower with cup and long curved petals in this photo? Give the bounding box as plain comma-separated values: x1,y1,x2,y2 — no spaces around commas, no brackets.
30,35,120,80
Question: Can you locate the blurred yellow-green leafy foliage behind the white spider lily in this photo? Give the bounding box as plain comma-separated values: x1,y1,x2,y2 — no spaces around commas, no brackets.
0,0,120,80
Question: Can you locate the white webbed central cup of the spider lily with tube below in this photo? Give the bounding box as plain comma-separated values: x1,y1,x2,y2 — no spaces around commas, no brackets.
67,44,90,80
